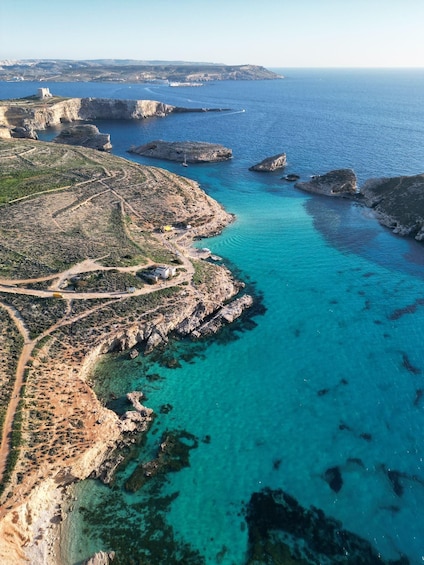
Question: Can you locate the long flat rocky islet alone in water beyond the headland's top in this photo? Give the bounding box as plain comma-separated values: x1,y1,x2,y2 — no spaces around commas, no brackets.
129,140,233,163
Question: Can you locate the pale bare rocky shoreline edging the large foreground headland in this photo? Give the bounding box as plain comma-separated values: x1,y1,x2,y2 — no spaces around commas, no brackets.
0,183,252,565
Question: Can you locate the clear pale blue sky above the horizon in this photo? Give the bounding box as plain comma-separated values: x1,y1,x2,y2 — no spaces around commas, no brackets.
0,0,424,68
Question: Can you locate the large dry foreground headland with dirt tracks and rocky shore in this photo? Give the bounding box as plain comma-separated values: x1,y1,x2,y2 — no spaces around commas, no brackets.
0,138,252,565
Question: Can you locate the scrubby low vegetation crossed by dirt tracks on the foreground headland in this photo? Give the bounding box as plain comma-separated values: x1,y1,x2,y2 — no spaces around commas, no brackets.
0,135,234,508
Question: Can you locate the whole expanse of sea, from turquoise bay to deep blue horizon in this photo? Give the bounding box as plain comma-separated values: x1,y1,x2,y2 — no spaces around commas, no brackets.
0,69,424,565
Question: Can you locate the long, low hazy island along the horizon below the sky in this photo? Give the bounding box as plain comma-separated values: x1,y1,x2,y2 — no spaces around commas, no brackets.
0,59,284,82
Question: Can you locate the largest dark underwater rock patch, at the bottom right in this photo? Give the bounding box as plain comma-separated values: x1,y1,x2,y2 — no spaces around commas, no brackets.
246,488,409,565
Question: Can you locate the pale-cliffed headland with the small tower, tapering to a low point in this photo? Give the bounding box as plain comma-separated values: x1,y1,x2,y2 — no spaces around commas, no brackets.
0,96,227,139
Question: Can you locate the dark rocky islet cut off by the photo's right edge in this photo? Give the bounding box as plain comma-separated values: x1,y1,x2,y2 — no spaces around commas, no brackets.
360,174,424,241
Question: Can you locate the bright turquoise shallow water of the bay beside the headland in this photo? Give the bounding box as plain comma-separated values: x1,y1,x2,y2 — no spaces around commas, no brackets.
67,184,424,564
